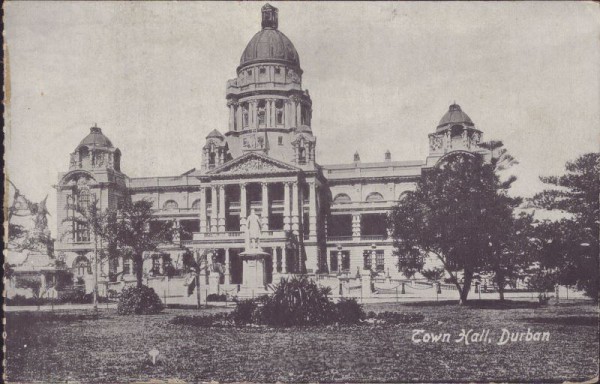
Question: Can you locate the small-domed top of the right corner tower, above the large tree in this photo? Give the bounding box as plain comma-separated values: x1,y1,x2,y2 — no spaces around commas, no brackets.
427,104,487,166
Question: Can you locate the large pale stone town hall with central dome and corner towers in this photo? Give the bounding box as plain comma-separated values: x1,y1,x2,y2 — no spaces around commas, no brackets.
55,4,485,294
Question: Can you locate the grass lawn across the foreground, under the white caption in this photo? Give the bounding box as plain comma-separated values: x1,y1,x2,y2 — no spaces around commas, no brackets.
5,302,598,382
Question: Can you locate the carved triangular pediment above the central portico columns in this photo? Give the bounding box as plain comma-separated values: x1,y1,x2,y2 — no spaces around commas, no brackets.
207,152,300,176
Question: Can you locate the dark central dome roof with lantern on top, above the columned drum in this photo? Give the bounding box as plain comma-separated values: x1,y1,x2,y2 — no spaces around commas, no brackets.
240,4,300,67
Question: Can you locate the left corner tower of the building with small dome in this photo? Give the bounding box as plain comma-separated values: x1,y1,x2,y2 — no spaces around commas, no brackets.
56,126,127,249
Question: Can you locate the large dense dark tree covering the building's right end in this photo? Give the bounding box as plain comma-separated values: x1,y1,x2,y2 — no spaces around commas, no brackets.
388,153,520,304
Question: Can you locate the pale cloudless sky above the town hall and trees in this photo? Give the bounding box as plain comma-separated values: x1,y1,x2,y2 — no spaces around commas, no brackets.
4,2,600,233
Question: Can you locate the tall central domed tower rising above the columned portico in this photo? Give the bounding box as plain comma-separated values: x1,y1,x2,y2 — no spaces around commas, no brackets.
220,4,315,167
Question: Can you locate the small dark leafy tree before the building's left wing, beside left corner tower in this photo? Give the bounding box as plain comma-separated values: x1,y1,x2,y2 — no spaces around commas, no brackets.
113,199,176,288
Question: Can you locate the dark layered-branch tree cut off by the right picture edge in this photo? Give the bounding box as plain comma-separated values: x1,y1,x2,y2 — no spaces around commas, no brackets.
532,153,600,301
